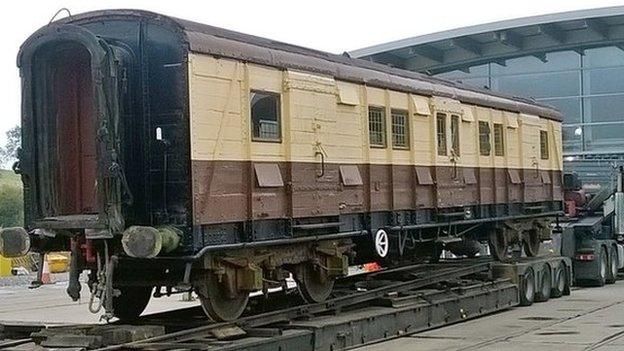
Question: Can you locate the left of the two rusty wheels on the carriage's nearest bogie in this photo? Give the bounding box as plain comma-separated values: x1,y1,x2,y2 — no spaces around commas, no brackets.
198,273,249,322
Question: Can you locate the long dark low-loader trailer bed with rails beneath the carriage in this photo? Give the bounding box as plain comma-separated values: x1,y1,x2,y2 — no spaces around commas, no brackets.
0,256,570,351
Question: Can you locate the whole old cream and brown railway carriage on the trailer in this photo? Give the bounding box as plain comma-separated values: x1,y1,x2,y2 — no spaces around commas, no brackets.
0,10,562,320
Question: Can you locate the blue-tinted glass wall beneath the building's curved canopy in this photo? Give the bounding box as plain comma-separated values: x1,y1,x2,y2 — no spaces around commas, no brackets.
438,47,624,155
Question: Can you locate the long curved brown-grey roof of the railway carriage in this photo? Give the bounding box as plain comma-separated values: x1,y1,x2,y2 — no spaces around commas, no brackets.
39,10,562,121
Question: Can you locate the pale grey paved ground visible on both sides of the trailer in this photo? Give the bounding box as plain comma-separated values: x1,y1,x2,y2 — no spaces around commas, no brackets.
0,281,624,351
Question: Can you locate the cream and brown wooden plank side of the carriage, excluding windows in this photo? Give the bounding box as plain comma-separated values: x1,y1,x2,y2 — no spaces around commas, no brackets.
188,54,562,225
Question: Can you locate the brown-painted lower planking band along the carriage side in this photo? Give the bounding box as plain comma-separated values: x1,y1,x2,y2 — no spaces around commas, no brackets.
191,161,563,225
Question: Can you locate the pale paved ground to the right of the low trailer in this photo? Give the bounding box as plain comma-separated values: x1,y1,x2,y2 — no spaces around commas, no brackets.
357,281,624,351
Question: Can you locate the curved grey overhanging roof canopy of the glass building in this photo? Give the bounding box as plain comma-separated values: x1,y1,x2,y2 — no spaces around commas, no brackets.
350,6,624,74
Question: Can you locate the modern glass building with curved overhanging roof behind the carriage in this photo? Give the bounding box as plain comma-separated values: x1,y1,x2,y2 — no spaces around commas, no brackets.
349,7,624,161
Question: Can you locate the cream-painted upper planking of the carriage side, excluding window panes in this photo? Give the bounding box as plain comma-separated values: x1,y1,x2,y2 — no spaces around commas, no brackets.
189,54,561,169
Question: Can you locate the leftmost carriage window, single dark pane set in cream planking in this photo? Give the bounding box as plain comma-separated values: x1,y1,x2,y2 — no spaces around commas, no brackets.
250,90,282,142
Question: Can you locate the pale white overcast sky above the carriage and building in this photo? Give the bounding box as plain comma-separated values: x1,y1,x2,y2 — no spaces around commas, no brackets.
0,0,624,145
